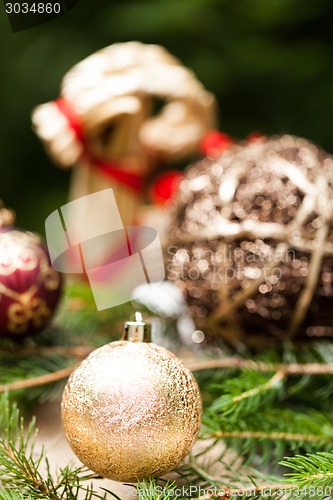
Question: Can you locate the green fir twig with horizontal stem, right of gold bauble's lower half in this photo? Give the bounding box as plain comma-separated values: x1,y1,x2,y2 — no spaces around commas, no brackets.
202,408,333,464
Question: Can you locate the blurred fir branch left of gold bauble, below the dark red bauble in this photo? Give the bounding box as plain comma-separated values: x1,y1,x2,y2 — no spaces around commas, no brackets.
0,284,160,402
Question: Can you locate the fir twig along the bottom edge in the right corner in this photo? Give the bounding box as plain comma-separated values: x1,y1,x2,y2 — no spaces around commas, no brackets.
177,452,333,500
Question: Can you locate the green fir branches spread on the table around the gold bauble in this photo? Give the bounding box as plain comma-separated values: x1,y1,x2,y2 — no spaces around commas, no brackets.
0,286,333,500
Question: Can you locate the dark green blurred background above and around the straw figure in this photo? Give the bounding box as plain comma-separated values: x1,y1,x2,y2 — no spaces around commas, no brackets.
0,0,333,233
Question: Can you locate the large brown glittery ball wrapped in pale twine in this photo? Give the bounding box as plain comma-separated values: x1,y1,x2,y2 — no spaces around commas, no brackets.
166,135,333,346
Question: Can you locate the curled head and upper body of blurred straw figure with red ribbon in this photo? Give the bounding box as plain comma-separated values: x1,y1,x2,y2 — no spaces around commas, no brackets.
32,42,216,234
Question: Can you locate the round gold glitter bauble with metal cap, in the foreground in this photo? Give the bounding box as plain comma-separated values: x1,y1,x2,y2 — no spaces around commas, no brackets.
62,318,201,482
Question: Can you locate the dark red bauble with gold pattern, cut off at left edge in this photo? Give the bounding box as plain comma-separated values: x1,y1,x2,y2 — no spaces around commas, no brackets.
0,208,62,338
